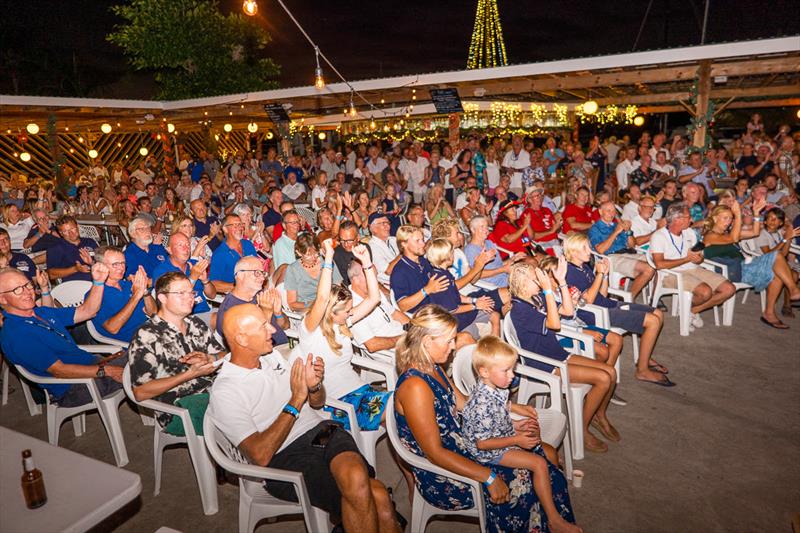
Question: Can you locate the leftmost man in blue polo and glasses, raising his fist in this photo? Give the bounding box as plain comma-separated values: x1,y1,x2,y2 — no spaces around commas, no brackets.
0,263,125,407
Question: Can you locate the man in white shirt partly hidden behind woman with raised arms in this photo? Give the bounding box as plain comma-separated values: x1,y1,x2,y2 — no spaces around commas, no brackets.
347,261,408,352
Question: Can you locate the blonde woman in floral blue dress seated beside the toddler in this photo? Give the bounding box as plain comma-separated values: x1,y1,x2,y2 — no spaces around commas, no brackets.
395,305,574,533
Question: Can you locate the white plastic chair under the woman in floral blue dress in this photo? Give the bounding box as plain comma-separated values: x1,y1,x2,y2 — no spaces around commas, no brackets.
386,401,486,533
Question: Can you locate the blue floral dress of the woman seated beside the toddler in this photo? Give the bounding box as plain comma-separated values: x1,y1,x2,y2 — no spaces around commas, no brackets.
395,366,575,533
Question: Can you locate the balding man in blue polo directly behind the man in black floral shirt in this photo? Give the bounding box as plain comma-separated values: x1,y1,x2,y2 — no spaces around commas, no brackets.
153,232,217,324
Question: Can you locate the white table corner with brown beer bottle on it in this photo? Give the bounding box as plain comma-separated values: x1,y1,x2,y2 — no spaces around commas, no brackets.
0,427,142,533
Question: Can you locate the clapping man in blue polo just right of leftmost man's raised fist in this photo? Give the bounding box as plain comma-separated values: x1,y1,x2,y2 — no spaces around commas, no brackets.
92,246,156,342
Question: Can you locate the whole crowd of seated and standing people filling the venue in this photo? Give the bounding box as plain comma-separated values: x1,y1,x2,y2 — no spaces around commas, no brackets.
0,111,800,532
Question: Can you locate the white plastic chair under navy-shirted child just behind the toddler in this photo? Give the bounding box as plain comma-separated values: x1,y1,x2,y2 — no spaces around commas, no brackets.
503,317,594,460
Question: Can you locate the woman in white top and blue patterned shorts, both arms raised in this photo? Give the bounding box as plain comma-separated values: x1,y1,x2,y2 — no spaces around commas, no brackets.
295,239,392,431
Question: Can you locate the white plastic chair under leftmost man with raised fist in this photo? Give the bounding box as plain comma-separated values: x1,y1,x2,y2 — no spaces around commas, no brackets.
15,346,128,467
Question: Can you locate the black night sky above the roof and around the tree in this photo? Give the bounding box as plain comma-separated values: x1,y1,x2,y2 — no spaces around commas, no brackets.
0,0,800,98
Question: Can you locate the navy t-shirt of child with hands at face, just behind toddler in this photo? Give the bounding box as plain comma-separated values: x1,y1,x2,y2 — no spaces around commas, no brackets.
509,298,569,372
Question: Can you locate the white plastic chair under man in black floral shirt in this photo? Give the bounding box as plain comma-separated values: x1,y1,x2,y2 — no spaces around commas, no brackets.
122,365,219,515
